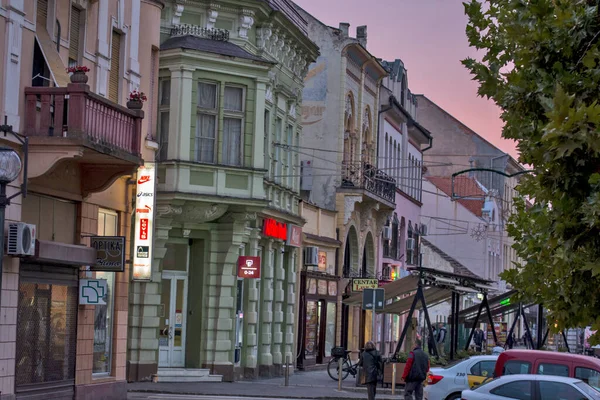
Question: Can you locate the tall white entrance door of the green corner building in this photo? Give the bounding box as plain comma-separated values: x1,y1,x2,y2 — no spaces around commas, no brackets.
158,271,188,367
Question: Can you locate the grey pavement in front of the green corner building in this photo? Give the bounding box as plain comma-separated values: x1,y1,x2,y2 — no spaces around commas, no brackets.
127,371,403,400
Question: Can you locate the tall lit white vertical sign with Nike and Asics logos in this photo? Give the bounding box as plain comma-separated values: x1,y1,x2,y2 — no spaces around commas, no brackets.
133,162,156,281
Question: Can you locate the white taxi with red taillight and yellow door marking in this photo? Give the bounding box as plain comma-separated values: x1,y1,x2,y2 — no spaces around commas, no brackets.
423,356,498,400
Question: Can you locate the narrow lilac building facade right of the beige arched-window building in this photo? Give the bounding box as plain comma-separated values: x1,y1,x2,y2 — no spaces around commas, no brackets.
375,59,432,355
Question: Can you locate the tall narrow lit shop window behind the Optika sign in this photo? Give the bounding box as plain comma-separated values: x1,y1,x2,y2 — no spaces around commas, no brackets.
92,209,119,375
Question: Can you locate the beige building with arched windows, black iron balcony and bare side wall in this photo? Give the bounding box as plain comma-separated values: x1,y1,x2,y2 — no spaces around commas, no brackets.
300,10,396,351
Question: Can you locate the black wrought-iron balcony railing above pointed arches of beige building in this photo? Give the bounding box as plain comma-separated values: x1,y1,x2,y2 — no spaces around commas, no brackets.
340,162,396,208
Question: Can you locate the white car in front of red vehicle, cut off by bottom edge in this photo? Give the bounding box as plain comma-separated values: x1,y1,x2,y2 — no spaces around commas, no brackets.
461,375,600,400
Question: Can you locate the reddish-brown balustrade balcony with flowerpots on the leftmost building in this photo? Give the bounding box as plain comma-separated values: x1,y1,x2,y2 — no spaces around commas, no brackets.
23,84,144,194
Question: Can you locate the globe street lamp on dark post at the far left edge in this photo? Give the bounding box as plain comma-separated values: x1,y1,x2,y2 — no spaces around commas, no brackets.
0,117,28,310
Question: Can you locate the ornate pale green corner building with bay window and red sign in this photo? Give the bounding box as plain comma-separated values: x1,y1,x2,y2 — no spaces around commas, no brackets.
128,0,318,381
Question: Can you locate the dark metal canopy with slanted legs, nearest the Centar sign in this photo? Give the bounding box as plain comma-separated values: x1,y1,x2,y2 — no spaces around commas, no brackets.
383,266,496,359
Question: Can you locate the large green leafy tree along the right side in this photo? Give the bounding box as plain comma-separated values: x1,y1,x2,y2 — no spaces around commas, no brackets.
463,0,600,342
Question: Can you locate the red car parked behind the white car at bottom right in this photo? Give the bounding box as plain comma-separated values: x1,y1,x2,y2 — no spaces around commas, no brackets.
494,350,600,389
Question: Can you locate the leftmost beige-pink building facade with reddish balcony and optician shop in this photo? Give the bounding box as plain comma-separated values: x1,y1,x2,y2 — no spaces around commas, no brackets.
0,0,162,399
